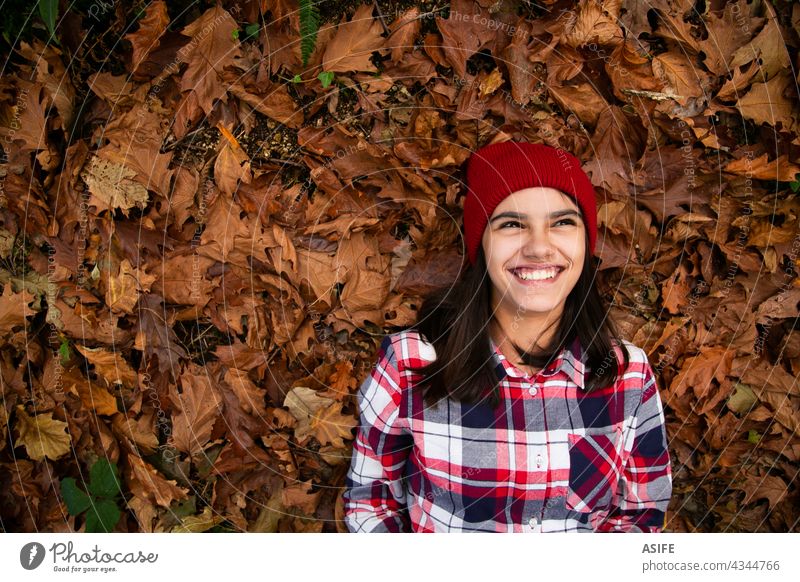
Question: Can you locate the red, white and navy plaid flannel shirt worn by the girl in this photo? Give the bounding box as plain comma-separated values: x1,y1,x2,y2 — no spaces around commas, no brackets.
343,330,672,532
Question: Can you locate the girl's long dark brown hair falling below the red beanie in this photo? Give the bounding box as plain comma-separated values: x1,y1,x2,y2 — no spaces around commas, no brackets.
408,237,628,407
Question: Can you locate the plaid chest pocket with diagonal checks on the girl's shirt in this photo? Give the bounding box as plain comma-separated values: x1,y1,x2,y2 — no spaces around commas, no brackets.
566,427,623,513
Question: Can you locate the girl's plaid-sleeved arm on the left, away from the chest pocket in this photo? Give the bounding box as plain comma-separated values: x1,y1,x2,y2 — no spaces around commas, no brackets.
343,335,413,532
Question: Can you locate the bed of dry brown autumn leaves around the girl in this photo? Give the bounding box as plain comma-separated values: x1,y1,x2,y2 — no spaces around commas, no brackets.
0,0,800,531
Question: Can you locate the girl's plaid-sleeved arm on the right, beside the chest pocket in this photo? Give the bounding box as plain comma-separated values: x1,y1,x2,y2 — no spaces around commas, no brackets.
597,363,672,532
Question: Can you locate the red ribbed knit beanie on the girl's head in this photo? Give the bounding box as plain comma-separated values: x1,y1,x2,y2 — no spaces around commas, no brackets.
464,141,597,265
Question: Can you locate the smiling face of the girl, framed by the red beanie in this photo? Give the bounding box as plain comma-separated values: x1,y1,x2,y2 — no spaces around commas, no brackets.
482,187,586,328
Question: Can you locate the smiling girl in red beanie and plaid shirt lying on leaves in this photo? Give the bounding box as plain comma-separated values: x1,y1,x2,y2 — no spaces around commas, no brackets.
344,142,672,532
